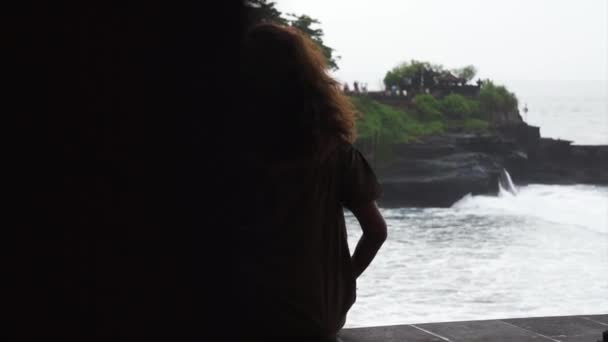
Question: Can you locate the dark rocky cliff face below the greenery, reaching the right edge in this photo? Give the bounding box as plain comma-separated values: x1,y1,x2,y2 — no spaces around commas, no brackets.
366,123,608,207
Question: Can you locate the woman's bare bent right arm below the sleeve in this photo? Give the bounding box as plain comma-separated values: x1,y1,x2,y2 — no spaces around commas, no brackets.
350,201,387,278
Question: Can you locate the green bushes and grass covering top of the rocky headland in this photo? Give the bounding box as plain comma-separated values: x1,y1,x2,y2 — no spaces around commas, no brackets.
352,60,517,150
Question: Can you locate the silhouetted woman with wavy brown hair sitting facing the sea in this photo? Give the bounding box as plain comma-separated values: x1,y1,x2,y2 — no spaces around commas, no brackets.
234,24,387,337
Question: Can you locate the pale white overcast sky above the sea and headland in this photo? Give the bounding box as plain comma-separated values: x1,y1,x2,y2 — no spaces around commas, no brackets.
274,0,608,89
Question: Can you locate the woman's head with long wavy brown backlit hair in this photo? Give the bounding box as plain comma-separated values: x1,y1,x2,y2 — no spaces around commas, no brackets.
242,24,355,155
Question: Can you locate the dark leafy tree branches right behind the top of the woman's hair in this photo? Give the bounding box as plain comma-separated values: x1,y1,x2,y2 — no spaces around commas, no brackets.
245,0,340,70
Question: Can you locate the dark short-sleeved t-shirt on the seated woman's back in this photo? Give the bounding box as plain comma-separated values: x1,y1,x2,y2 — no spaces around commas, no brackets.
237,143,381,335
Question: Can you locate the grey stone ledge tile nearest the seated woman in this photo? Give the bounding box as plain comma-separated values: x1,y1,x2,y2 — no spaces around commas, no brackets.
338,325,445,342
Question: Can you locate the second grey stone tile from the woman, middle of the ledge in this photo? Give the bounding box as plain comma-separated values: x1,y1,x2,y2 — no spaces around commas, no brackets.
416,320,551,342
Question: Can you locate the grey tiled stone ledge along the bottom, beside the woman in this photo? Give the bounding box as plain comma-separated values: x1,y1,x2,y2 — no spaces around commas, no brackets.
338,314,608,342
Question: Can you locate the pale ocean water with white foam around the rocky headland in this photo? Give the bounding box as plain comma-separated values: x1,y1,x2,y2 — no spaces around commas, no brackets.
345,81,608,328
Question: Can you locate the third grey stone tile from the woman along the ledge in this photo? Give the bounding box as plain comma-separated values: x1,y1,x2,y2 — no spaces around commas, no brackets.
503,316,608,342
